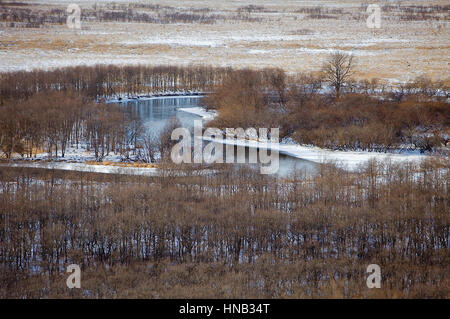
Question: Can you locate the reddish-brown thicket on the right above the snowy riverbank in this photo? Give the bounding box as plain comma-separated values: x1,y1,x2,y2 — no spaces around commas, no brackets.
206,70,450,151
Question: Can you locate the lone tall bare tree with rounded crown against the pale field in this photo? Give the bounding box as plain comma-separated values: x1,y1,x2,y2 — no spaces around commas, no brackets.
322,52,354,98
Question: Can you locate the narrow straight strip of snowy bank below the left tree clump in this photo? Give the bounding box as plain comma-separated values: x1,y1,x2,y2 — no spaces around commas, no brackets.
0,162,158,176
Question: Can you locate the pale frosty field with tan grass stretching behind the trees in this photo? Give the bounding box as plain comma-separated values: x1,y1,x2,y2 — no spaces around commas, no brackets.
0,0,450,83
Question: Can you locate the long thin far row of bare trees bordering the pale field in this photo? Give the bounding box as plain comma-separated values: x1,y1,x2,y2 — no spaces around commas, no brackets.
0,65,230,104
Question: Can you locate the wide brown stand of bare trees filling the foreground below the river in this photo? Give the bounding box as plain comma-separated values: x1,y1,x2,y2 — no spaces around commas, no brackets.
0,162,450,298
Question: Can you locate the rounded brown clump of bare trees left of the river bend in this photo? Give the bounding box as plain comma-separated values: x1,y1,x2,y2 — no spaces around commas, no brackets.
0,90,141,160
